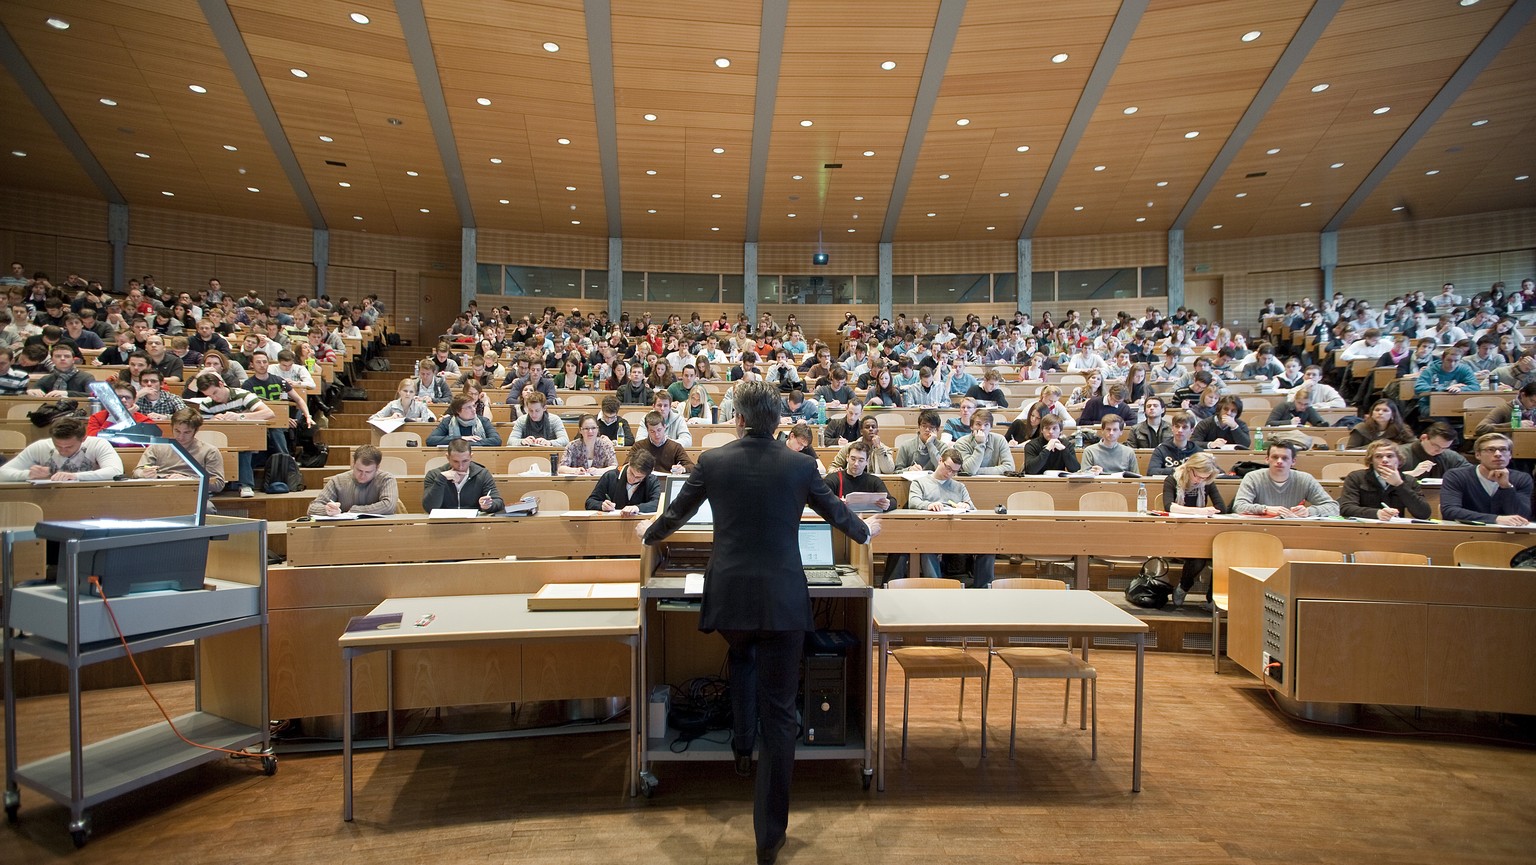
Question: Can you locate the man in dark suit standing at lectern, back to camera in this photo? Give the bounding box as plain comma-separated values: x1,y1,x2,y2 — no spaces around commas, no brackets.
636,381,880,863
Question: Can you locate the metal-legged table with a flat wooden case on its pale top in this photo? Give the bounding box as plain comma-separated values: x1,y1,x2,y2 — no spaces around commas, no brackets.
336,595,645,822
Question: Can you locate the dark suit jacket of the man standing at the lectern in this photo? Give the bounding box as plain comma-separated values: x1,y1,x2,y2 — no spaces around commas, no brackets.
645,433,869,631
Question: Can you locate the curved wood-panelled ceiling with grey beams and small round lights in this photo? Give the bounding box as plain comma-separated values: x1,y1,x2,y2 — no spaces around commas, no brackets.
0,0,1536,243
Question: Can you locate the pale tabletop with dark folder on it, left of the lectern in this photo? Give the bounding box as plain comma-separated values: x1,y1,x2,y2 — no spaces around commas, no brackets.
336,595,641,648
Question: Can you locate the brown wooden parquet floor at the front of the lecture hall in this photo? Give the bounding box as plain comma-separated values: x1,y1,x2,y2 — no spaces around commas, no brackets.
0,651,1536,865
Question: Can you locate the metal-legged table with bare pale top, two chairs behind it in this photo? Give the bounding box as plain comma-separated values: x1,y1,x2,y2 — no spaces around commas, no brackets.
874,593,1147,793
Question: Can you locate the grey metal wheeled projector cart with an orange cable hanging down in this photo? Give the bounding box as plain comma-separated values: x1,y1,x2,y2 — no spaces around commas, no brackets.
0,516,276,847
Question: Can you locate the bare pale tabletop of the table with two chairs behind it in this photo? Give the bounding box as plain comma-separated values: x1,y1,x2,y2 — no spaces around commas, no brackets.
874,588,1147,635
